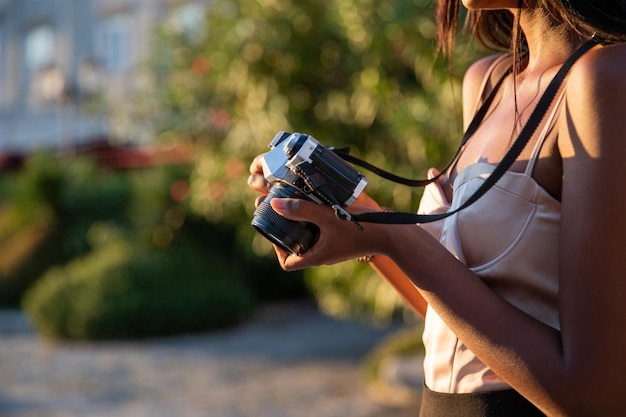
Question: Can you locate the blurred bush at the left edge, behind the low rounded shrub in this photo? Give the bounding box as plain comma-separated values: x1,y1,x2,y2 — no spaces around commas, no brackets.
0,153,131,305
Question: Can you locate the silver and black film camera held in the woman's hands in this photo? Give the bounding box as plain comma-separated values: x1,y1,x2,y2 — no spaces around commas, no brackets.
251,131,367,255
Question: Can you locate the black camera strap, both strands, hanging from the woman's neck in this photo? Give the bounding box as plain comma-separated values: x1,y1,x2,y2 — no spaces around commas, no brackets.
334,39,597,224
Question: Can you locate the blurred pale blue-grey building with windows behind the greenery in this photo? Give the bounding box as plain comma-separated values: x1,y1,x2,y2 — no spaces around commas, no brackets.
0,0,207,155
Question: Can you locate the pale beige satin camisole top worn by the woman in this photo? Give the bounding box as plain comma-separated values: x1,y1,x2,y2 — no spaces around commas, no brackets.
418,59,564,393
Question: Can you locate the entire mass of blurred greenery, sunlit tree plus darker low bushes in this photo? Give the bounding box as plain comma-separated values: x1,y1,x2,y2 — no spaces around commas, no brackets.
0,0,490,339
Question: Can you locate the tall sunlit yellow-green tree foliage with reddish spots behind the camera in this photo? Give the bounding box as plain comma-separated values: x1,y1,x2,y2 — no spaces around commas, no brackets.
127,0,476,318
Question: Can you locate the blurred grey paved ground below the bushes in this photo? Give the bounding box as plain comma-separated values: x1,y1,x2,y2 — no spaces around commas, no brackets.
0,304,417,417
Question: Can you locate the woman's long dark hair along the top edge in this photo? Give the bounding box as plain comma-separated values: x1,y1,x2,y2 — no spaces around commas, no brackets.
437,0,626,57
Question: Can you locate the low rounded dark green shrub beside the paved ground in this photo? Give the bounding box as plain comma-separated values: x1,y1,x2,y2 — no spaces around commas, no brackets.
24,239,254,340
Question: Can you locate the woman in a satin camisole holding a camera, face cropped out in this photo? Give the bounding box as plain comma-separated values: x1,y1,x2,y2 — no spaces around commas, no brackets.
249,0,626,417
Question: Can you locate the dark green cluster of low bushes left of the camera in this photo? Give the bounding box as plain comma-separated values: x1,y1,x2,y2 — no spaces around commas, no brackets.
0,152,307,339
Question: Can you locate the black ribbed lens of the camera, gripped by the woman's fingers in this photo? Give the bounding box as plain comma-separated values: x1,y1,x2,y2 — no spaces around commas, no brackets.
251,182,319,255
